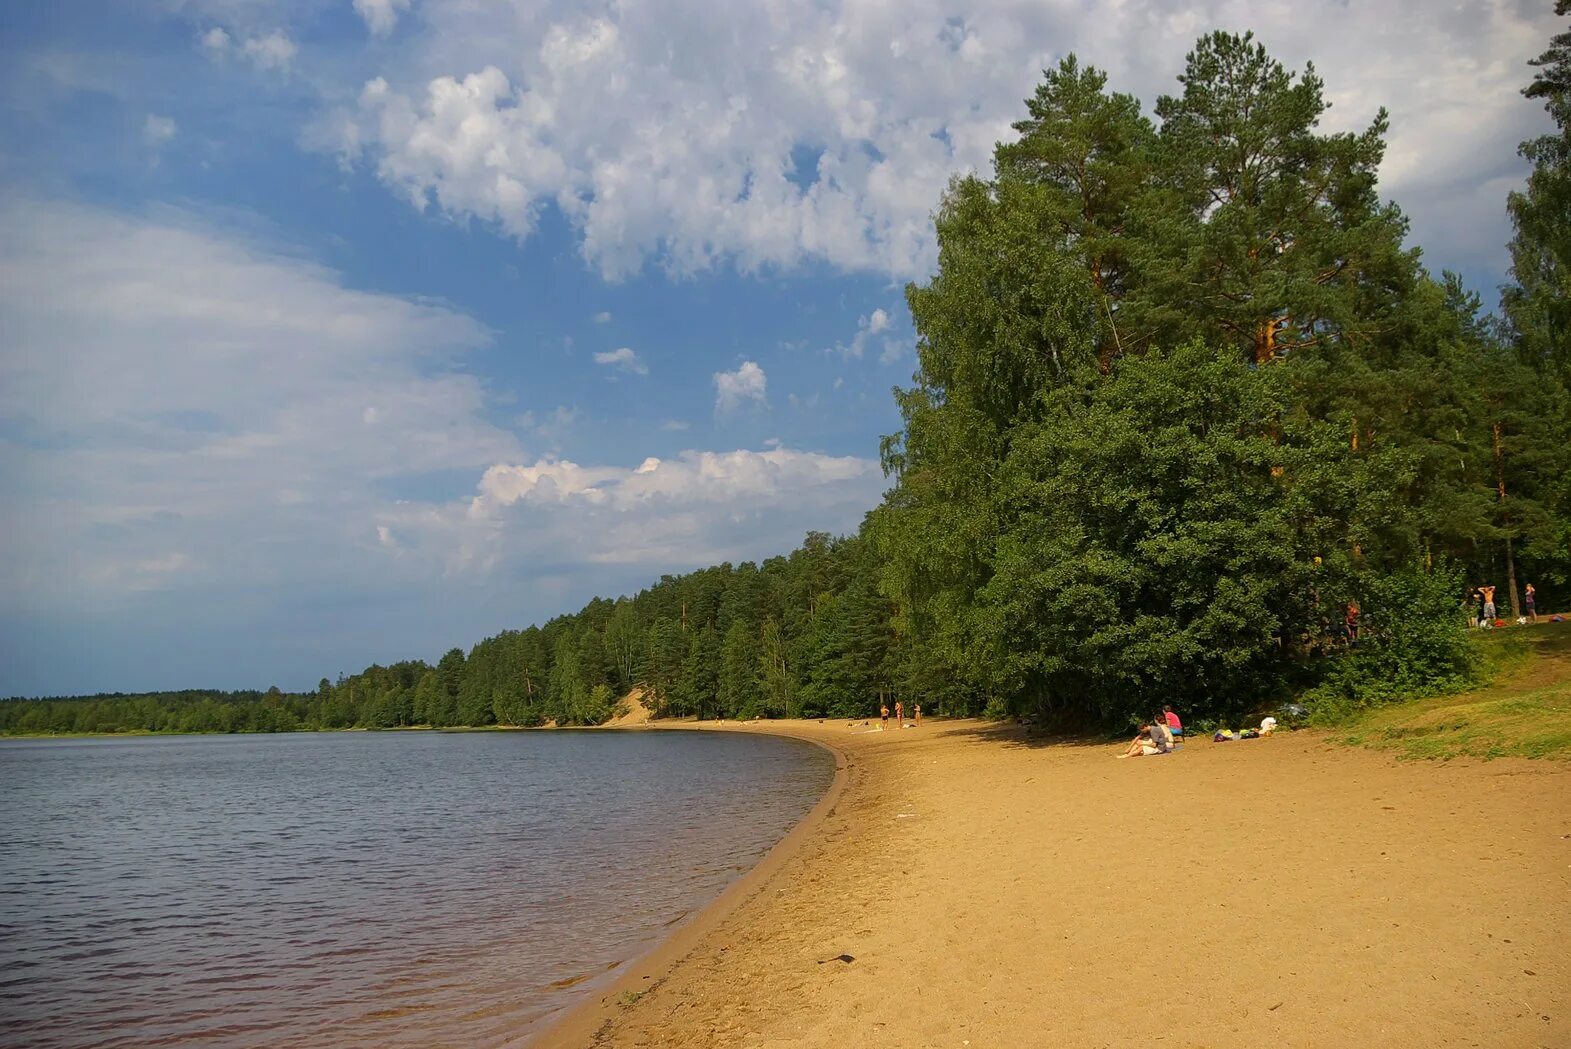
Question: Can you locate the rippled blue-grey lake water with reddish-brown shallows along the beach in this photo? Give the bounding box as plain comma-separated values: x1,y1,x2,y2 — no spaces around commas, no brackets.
0,732,834,1047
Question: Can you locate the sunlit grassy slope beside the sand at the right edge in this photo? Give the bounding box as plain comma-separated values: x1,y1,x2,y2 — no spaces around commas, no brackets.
1334,623,1571,760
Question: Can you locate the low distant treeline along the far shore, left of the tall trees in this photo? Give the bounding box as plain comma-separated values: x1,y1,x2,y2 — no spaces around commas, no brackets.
0,532,903,733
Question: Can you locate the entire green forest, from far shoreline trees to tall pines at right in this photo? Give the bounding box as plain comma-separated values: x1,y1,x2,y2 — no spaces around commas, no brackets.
0,20,1571,733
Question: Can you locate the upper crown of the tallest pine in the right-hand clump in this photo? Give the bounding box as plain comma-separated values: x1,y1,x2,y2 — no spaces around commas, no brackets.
1130,33,1415,363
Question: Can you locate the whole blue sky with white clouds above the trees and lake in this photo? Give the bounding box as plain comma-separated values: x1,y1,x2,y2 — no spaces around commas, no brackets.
0,0,1557,696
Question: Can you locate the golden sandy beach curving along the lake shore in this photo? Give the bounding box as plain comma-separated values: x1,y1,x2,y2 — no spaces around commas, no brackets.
545,722,1571,1049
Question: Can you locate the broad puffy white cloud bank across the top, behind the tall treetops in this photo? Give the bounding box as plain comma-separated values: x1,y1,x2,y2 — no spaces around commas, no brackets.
328,0,1555,287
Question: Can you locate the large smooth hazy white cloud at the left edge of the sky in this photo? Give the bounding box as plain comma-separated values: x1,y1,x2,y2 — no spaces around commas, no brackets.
0,199,520,612
